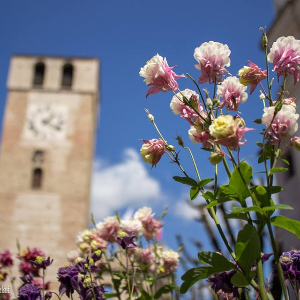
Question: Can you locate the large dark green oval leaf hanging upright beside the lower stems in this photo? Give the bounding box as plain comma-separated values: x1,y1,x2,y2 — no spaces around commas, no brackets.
235,224,261,275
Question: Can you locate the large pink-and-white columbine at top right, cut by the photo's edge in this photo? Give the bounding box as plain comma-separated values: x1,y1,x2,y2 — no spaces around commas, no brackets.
268,36,300,84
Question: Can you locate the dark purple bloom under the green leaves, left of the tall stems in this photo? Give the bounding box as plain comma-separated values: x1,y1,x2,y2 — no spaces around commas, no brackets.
207,270,239,297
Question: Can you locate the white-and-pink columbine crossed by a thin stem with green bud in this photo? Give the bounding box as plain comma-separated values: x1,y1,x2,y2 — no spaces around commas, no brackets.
170,89,203,124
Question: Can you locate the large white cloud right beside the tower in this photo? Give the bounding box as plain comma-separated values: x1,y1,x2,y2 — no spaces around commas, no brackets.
91,148,162,221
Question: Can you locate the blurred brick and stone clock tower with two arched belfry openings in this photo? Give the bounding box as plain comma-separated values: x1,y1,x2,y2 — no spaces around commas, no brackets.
0,55,99,279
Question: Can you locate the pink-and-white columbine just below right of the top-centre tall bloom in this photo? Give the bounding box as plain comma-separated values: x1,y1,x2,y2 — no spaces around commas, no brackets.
217,76,248,111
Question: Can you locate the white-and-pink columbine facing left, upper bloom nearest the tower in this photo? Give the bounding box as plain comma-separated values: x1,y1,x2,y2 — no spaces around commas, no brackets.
140,54,185,97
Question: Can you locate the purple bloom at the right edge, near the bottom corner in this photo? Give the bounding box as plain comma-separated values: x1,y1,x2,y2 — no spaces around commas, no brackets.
279,250,300,282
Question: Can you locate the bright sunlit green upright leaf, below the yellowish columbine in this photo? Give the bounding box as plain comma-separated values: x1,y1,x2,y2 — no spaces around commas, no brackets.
229,162,252,202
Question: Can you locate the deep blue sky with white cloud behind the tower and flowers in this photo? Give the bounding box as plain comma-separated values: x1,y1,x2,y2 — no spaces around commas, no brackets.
0,0,274,284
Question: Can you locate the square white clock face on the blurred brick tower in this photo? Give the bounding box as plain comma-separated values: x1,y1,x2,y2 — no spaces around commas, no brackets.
25,105,67,140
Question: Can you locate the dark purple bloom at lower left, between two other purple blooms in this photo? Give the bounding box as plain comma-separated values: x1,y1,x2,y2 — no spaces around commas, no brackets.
57,265,78,298
